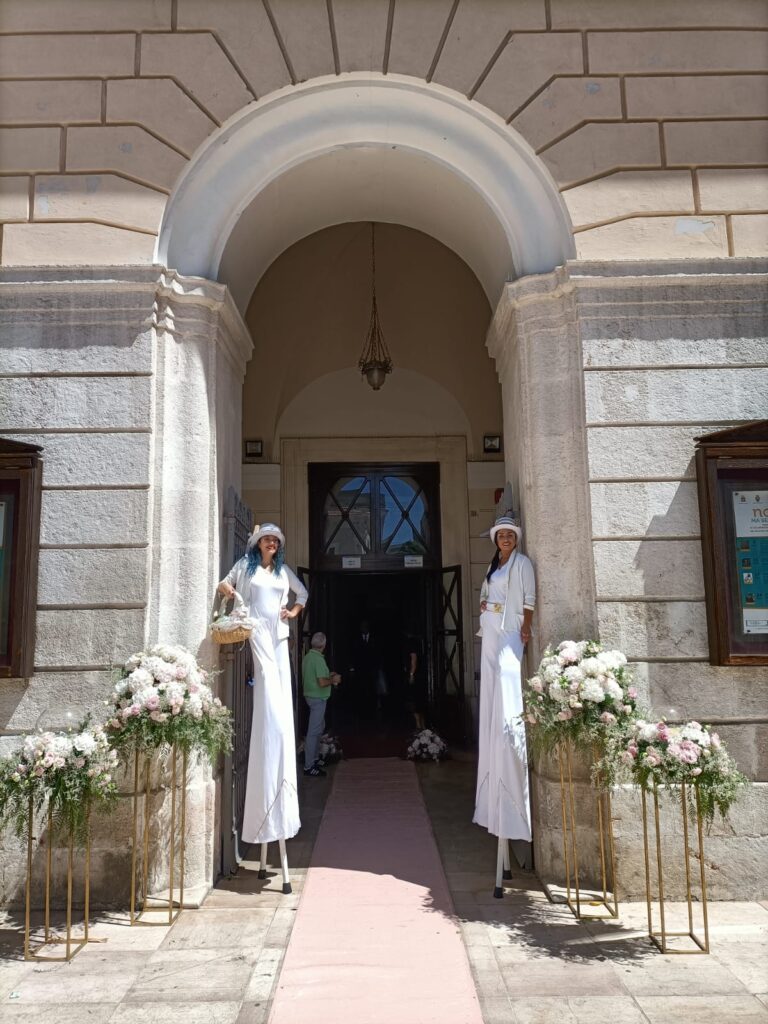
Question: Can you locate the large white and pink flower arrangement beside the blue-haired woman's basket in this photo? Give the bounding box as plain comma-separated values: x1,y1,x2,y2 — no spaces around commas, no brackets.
106,644,231,760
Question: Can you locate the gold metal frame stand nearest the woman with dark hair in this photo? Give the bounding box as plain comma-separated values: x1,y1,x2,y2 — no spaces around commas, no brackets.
557,743,618,921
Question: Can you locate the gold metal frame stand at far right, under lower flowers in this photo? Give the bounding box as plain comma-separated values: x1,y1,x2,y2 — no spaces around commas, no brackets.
641,782,710,954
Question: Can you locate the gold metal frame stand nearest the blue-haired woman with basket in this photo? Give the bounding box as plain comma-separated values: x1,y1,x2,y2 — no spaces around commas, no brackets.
130,745,187,926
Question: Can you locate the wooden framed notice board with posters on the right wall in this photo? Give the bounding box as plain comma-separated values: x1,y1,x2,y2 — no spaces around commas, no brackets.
696,420,768,665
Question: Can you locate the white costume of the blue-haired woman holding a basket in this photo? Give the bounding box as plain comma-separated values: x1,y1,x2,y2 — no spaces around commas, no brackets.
225,557,307,843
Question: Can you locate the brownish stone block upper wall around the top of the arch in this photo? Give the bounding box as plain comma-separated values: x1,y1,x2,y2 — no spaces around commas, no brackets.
0,0,768,266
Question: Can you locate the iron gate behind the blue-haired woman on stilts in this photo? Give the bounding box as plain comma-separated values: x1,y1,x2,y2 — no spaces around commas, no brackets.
221,487,253,874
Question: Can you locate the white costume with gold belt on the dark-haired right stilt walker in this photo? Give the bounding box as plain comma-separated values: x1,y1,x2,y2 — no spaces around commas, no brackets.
472,548,536,842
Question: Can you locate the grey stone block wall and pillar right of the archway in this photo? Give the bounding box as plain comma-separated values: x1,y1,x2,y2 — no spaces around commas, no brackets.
488,260,768,898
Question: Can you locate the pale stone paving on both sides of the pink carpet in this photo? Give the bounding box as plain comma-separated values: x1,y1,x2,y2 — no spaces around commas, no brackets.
0,760,768,1024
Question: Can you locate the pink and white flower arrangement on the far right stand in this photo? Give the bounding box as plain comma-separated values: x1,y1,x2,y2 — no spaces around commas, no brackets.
622,719,746,822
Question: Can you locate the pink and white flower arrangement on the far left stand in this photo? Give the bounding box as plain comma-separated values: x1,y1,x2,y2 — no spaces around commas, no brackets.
0,720,118,839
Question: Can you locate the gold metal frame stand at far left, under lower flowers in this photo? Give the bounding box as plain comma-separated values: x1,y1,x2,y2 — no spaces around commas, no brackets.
24,798,106,962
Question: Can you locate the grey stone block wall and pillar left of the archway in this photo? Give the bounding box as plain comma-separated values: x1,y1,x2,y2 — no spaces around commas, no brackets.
0,267,252,905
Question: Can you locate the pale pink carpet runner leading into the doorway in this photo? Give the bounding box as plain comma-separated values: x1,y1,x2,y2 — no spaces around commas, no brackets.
269,758,482,1024
